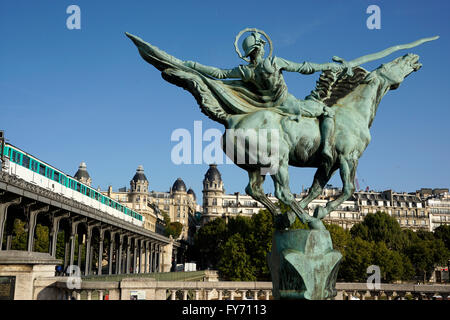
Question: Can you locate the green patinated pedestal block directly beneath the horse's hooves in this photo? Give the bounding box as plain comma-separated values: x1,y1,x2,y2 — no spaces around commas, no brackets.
267,230,342,300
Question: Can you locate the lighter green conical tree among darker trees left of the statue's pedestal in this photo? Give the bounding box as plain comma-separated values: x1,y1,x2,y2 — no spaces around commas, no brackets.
217,233,256,281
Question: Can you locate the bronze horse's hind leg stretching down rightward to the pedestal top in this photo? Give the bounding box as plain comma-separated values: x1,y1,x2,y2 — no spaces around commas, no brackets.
272,159,325,229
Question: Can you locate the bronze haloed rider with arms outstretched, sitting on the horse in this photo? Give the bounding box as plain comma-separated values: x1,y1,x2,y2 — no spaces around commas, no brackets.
184,32,344,170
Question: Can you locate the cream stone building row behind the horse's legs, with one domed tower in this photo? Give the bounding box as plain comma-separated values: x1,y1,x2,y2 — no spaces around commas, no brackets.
201,165,440,231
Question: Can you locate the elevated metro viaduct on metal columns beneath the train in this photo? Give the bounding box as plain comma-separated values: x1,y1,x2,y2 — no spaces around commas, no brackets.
0,171,179,275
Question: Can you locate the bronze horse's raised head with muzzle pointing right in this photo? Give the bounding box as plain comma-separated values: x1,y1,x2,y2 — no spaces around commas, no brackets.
373,53,422,90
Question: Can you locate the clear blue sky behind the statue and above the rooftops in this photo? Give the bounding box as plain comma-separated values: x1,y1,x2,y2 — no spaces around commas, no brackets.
0,0,450,202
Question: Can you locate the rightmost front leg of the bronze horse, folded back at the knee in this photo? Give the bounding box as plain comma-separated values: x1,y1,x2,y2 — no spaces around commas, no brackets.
314,156,358,219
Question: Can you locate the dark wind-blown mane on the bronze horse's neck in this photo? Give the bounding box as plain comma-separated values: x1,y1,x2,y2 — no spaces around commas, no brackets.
306,67,369,107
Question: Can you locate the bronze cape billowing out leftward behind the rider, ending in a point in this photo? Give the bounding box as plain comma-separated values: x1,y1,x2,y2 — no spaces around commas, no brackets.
126,33,268,125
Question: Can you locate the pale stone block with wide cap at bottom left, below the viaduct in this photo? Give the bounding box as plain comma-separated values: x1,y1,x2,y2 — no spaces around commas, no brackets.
0,250,61,300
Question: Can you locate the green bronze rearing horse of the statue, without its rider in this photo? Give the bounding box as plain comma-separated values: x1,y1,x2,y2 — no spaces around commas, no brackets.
223,54,422,229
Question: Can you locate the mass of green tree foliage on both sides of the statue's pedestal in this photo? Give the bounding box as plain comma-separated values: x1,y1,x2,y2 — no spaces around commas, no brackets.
193,204,450,282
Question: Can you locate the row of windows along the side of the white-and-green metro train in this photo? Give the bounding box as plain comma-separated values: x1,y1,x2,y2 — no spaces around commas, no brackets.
5,147,142,221
